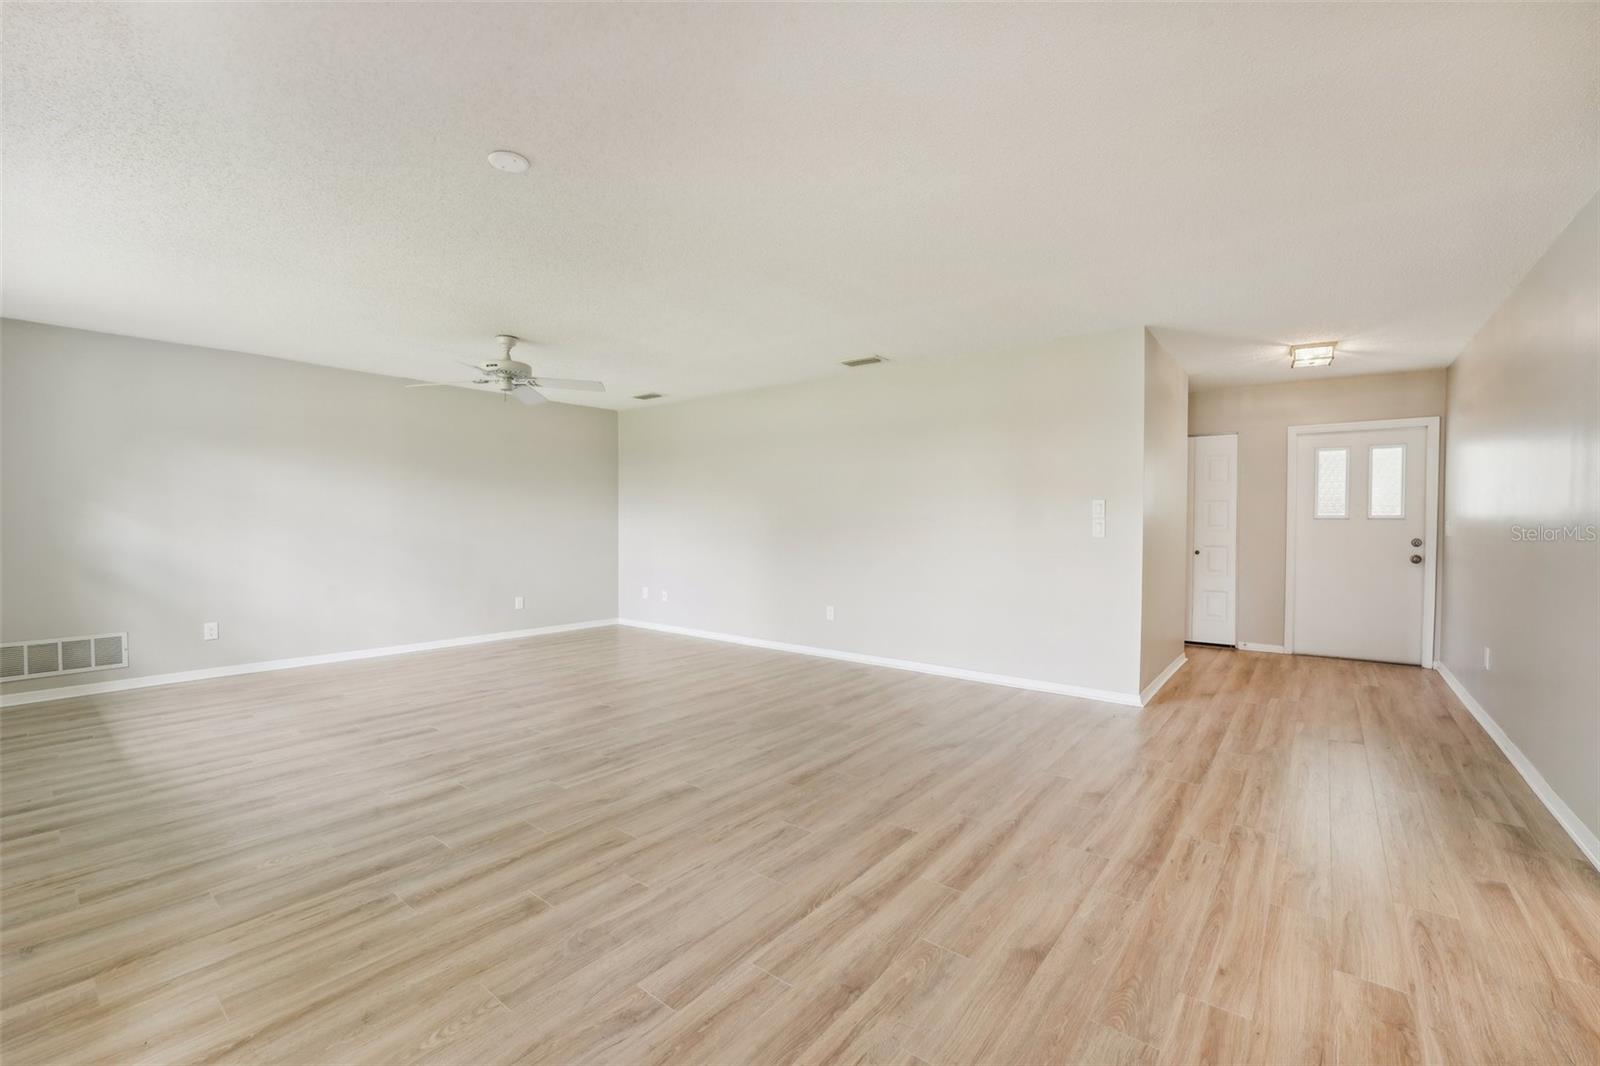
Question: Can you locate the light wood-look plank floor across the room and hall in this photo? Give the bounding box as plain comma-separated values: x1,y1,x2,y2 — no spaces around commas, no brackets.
0,629,1600,1066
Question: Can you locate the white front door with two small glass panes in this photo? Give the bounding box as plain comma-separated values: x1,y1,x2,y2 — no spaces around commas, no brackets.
1286,424,1437,664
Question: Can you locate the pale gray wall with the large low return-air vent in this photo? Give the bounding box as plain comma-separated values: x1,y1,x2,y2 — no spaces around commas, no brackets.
0,320,616,693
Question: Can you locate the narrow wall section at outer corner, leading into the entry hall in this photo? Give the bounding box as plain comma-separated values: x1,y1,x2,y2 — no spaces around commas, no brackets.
1139,330,1189,690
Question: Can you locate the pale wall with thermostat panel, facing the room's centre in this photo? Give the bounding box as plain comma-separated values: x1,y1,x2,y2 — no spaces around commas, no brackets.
618,328,1158,693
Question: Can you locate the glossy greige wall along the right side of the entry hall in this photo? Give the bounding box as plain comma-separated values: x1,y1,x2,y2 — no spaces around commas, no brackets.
1442,191,1600,834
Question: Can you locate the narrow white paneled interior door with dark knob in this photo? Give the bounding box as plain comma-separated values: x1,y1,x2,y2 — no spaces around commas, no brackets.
1189,434,1238,643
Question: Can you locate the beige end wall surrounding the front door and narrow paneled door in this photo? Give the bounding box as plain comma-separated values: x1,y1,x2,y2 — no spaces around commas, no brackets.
1189,370,1450,645
